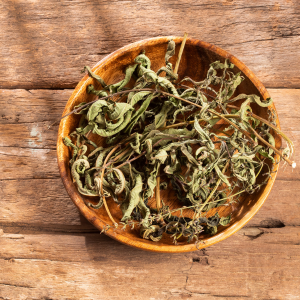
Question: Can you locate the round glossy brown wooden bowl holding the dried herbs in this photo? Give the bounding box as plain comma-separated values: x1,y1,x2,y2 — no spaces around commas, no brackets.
57,37,281,253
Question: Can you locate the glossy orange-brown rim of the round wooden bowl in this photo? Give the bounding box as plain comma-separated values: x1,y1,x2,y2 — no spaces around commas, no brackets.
57,36,280,253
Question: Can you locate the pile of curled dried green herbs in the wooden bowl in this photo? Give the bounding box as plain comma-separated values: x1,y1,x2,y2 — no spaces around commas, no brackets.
64,40,294,244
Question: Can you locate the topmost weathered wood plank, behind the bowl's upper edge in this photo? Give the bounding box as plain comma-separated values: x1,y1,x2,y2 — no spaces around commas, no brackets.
0,0,300,89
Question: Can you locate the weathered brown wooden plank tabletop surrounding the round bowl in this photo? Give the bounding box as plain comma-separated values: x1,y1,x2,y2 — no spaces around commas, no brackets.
0,0,300,300
